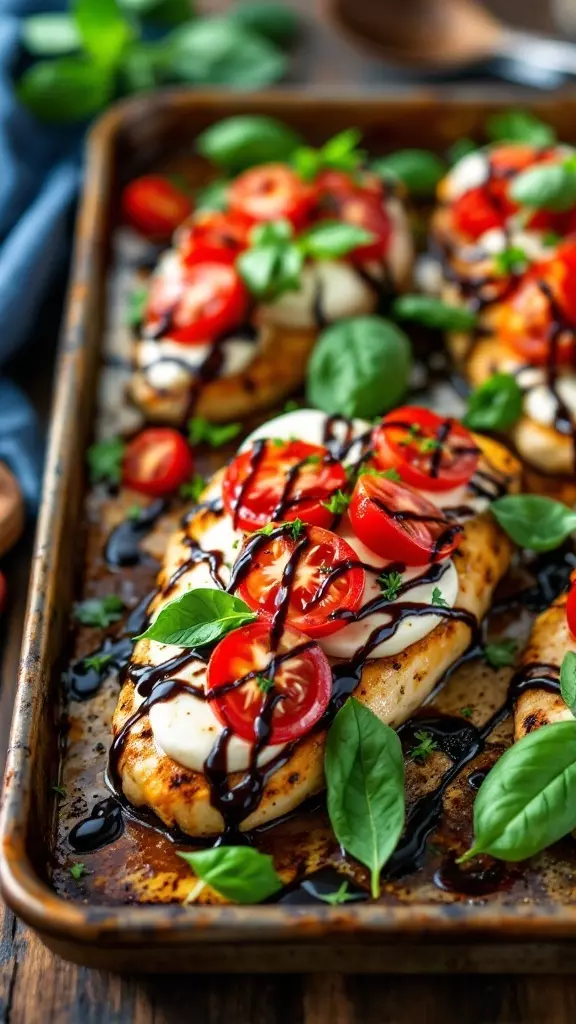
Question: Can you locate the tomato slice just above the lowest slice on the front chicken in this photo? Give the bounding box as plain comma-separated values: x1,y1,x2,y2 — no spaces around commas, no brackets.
238,526,366,637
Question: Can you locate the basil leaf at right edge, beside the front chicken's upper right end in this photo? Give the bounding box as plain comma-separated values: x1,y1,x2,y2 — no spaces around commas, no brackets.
490,495,576,551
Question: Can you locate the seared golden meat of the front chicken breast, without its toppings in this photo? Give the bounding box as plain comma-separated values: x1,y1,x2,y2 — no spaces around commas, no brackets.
113,437,520,836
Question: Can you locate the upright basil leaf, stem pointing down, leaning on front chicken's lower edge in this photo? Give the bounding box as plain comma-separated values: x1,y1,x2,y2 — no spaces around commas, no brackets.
325,697,404,898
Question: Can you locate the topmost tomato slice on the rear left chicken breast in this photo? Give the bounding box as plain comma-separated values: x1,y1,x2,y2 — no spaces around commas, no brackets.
229,164,316,227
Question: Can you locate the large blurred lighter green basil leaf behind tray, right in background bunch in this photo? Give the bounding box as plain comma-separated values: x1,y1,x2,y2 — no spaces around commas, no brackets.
166,17,286,89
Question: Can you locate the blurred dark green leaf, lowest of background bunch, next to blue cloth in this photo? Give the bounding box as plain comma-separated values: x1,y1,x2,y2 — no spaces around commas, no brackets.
16,57,114,123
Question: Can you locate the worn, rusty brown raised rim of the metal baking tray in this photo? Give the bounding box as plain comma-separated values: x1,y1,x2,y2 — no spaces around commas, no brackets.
0,91,576,973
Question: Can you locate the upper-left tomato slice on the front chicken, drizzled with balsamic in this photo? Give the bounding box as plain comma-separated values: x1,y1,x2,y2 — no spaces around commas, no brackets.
222,439,346,531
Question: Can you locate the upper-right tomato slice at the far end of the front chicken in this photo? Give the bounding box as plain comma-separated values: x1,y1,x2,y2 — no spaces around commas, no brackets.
373,406,479,490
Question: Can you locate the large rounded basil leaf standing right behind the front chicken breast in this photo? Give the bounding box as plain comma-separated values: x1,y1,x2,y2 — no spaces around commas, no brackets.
306,316,412,420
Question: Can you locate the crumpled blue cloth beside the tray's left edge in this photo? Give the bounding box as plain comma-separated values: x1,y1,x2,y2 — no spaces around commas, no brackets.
0,0,83,511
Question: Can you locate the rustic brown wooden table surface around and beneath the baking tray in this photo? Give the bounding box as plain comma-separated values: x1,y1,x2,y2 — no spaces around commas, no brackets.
0,0,576,1024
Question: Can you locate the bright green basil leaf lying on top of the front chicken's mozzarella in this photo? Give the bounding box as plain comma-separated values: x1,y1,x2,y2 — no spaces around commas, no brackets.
135,589,256,647
